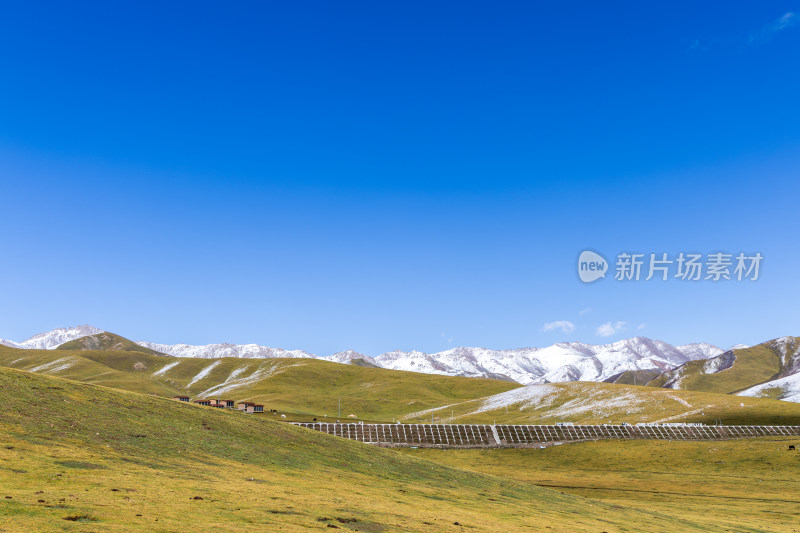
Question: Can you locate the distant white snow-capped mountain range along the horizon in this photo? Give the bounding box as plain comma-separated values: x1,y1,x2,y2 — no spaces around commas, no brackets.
0,326,723,385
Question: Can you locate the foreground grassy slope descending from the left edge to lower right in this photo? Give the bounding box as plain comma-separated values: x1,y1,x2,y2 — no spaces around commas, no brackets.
0,369,707,532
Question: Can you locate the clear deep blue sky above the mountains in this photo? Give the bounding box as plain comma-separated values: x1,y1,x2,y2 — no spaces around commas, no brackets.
0,1,800,355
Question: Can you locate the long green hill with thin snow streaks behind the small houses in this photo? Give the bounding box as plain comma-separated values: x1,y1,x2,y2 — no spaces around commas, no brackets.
0,347,520,421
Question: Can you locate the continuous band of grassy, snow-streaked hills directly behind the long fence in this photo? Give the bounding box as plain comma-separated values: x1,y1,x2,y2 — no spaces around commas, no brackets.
7,347,800,424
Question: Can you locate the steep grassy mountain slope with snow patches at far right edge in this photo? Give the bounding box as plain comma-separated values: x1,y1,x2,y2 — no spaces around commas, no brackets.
649,337,800,397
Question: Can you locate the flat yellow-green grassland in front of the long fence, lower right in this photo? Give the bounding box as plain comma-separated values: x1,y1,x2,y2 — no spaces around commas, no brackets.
402,437,800,532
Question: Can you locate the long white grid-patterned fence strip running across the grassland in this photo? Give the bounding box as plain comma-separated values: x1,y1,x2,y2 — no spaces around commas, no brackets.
295,422,800,448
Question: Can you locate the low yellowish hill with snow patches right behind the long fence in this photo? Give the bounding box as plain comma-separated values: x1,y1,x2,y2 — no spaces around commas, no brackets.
401,381,800,425
